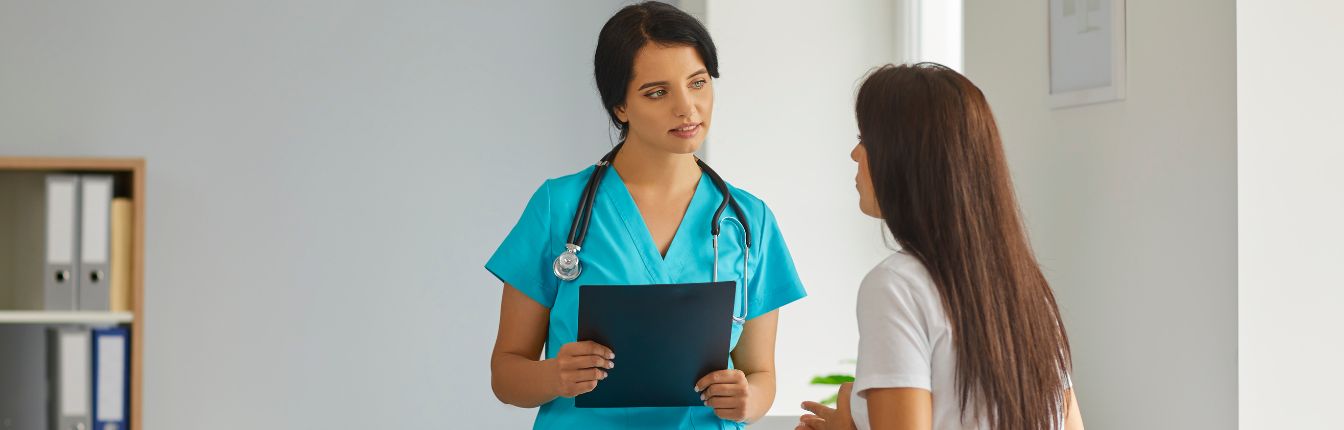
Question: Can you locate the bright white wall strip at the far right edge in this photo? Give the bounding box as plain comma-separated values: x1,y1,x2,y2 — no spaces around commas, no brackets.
1236,0,1344,429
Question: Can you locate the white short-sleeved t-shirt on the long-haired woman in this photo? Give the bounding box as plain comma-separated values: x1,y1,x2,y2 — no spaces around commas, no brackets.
849,251,1067,430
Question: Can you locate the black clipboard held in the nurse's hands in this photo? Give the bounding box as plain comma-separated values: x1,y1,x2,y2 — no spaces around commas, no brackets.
574,281,737,407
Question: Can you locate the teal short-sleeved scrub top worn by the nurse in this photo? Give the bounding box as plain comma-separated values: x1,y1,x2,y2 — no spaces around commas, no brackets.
485,162,806,429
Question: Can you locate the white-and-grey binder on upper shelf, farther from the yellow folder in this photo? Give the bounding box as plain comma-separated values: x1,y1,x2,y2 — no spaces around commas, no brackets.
43,175,79,310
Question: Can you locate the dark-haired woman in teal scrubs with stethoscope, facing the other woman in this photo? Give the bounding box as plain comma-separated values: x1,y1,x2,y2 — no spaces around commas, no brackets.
485,1,806,429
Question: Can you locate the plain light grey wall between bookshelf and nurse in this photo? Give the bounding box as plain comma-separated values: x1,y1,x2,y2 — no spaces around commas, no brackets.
0,0,621,430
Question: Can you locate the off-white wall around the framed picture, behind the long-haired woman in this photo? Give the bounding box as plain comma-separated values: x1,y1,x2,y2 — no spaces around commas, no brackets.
965,0,1236,430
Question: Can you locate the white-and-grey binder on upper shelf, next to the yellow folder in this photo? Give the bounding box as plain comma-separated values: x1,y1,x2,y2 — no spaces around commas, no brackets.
77,175,112,312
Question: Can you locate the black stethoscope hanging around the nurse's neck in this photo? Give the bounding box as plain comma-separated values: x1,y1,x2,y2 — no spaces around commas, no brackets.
551,142,751,324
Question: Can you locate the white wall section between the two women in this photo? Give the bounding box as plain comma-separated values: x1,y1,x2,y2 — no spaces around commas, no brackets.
706,0,892,419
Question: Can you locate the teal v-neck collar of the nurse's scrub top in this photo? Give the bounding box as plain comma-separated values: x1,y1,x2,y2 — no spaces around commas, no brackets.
601,168,710,284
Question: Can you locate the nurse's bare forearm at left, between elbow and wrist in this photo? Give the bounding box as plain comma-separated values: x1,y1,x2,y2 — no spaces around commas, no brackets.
491,353,559,407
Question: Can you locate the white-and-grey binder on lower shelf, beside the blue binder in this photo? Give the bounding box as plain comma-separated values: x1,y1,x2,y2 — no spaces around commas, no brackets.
47,328,93,430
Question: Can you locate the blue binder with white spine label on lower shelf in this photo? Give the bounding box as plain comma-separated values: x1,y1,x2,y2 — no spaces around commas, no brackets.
93,327,130,430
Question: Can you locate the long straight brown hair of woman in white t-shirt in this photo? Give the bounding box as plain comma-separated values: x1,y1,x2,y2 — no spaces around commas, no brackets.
855,63,1073,430
